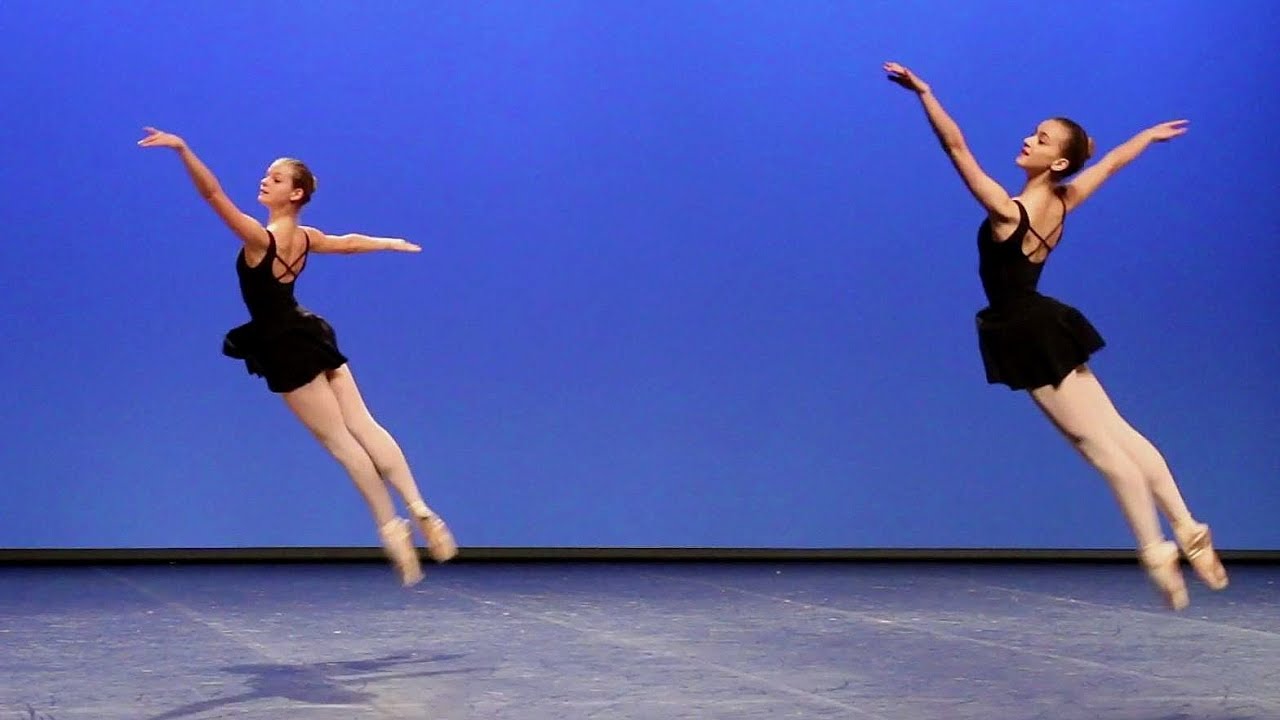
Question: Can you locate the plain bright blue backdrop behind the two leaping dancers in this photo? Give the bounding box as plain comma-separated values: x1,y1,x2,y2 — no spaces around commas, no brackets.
0,0,1280,548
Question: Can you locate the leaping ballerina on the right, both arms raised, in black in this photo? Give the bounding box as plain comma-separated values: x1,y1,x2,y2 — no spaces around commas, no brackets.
883,63,1228,610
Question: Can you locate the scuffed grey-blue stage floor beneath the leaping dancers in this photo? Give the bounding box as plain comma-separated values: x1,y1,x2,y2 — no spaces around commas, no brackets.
0,562,1280,720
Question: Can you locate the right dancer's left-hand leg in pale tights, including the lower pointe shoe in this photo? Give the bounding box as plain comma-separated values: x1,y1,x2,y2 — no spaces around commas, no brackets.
1030,366,1188,610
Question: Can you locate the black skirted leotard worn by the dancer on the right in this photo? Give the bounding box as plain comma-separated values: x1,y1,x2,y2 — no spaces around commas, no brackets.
975,200,1106,389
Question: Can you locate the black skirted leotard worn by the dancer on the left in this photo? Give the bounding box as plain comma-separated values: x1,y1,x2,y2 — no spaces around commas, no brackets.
223,231,347,393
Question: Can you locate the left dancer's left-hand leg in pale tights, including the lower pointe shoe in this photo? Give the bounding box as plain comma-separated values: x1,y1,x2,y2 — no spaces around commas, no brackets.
283,374,422,585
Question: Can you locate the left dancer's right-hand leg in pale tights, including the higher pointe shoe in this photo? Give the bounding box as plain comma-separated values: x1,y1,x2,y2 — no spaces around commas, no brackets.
328,365,457,562
